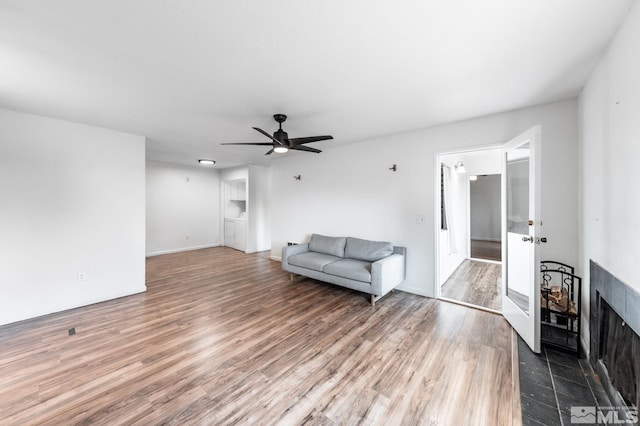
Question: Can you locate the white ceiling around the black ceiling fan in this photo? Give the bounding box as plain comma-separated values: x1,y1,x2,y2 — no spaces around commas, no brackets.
0,0,633,167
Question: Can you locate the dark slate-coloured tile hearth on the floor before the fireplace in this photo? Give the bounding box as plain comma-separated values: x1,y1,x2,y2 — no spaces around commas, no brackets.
518,338,610,426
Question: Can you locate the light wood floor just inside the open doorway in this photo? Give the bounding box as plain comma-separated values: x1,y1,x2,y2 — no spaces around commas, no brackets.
440,259,502,311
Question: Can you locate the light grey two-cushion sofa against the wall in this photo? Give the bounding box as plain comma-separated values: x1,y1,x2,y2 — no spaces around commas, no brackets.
282,234,407,306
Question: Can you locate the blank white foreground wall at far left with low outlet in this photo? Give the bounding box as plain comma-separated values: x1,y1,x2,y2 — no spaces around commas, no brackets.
0,109,146,324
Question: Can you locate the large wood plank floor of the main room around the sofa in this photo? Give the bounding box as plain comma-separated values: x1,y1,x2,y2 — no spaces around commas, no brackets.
0,247,519,426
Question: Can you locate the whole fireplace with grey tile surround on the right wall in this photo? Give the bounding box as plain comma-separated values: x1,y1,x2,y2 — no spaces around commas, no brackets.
589,261,640,412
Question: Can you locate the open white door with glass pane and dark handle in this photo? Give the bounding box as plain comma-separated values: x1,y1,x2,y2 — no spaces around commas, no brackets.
502,126,542,352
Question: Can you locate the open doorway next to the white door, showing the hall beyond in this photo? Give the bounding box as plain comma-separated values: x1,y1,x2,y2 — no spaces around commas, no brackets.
436,147,502,313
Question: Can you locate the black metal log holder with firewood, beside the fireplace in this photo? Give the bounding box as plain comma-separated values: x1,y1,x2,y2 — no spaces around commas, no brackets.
540,260,582,358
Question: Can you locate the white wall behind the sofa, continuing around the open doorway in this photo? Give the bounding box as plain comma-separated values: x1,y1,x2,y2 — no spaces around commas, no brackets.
271,99,578,296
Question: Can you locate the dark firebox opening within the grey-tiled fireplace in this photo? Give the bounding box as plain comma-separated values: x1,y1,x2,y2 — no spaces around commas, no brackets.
599,298,640,409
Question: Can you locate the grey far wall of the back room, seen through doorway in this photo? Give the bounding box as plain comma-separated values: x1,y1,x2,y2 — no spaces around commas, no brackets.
469,175,502,241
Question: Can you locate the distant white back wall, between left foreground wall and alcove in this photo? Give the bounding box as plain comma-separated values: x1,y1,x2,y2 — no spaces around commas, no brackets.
146,162,221,256
